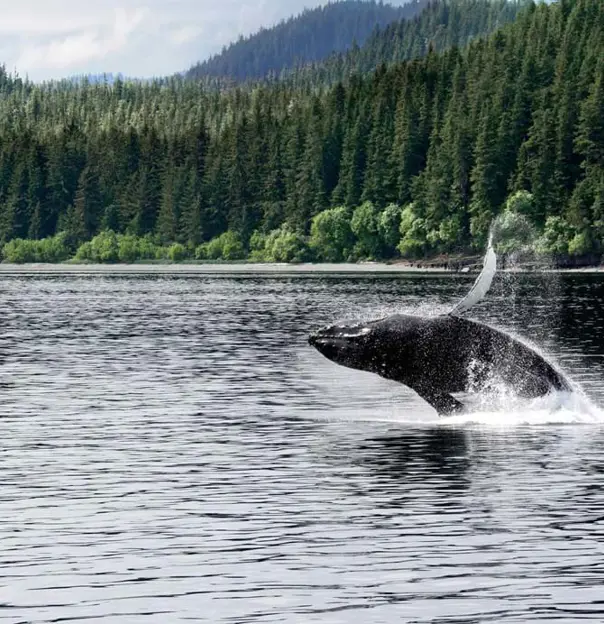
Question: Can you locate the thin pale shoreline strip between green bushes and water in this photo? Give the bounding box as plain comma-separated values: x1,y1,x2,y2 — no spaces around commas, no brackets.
0,262,604,275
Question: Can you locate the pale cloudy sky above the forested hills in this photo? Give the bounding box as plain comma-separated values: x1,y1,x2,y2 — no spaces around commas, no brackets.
0,0,402,81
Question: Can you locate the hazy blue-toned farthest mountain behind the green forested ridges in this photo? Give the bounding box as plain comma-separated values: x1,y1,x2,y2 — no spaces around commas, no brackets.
185,0,428,82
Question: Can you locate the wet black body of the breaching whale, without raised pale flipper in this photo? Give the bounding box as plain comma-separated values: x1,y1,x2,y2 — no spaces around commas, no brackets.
309,315,570,414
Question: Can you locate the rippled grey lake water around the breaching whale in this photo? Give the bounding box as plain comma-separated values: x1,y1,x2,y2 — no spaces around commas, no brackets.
0,273,604,624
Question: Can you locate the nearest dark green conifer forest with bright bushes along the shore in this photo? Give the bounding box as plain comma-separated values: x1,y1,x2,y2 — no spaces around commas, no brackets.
0,0,604,261
